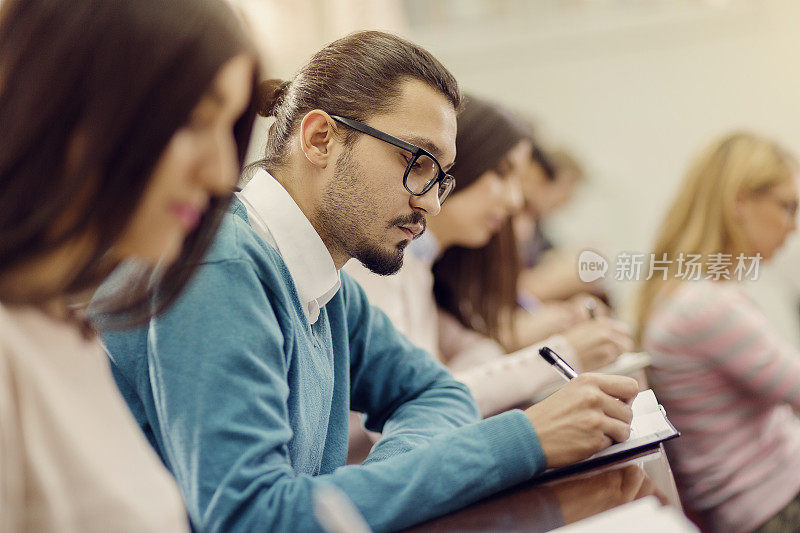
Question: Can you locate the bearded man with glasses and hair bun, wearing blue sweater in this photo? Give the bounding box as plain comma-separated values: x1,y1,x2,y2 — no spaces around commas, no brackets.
104,32,637,532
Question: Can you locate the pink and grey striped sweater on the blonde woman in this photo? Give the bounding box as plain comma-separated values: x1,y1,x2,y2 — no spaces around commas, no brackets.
643,281,800,533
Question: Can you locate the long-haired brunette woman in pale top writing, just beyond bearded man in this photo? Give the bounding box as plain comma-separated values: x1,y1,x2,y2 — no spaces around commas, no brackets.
346,97,632,416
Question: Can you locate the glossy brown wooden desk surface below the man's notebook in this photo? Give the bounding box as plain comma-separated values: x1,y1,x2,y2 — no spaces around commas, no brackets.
406,446,680,533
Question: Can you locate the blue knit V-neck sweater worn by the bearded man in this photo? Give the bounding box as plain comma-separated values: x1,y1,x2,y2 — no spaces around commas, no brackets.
103,202,545,532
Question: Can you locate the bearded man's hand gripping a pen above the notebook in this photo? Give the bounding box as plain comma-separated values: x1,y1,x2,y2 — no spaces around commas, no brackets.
525,374,639,468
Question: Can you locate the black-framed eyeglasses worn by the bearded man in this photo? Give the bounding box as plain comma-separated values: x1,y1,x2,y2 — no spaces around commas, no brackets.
331,115,456,205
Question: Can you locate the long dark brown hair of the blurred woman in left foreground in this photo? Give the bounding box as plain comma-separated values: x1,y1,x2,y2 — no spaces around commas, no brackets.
0,0,256,321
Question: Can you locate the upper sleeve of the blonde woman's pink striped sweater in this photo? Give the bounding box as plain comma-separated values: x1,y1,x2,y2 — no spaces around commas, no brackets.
664,282,800,410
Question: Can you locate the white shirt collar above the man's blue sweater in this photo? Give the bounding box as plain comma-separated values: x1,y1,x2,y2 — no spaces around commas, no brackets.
237,169,341,324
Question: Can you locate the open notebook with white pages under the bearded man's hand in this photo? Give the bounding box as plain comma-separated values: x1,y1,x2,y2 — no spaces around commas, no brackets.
540,389,680,479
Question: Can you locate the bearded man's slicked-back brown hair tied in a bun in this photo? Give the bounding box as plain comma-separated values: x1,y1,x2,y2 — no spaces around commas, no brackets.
250,31,461,170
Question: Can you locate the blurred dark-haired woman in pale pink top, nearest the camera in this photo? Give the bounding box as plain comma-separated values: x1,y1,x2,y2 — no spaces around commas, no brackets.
0,0,256,531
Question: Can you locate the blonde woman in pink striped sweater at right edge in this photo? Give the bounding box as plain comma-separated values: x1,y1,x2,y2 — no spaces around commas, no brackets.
638,133,800,533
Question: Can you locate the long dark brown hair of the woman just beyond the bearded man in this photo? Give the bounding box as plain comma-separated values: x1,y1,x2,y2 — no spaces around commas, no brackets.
433,97,530,340
